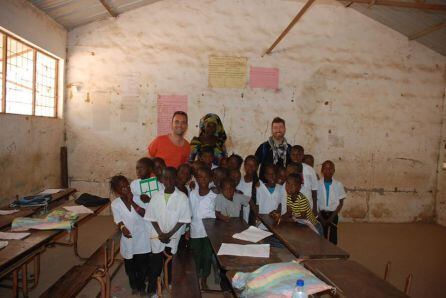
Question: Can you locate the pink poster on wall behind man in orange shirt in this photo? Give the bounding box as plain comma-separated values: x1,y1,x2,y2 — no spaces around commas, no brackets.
157,95,187,136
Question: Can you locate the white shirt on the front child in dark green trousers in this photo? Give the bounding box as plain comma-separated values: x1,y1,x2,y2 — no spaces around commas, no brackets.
189,189,217,238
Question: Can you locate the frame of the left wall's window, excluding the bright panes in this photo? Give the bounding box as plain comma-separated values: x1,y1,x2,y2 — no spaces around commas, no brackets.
0,29,60,118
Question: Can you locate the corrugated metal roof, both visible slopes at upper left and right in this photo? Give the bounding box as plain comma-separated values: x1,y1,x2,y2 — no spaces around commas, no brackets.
29,0,446,56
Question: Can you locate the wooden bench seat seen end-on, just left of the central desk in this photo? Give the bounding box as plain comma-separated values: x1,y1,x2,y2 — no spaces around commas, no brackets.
172,247,201,298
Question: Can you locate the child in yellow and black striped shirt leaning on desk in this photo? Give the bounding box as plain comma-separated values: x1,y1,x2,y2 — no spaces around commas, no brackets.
283,174,324,235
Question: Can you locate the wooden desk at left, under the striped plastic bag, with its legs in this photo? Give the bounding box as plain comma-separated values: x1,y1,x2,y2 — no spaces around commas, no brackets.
0,201,109,297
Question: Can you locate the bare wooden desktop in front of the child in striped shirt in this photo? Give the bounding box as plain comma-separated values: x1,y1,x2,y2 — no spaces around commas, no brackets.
259,214,350,259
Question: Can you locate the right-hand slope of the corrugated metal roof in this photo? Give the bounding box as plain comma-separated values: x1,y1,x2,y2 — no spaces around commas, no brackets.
342,0,446,56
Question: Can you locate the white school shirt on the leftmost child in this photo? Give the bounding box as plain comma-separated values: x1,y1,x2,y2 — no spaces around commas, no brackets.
111,196,151,259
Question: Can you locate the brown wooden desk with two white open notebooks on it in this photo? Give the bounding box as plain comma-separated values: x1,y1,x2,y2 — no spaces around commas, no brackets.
203,218,295,272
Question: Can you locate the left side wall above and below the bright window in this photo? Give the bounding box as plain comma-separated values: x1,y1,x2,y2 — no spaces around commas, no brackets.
0,0,67,203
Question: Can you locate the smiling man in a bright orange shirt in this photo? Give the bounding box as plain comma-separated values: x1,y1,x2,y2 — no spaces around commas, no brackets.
148,111,190,168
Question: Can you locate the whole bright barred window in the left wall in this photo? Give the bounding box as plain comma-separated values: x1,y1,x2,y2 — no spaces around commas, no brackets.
0,32,58,117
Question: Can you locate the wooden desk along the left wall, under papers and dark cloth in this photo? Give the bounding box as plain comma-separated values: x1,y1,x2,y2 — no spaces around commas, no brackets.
0,188,76,230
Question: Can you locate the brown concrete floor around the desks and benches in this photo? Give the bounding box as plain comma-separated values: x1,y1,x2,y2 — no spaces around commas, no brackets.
0,216,446,298
